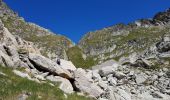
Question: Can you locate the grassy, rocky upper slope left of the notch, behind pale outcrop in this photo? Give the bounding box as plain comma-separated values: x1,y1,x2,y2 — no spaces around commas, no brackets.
0,1,73,59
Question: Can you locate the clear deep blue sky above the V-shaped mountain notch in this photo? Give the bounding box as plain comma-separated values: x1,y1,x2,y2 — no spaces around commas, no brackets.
4,0,170,43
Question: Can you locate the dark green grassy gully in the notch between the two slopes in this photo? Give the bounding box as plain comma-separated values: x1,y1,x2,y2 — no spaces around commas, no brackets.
67,46,97,69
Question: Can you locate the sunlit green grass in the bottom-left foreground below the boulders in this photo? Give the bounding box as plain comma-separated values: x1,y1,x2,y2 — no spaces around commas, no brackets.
0,66,93,100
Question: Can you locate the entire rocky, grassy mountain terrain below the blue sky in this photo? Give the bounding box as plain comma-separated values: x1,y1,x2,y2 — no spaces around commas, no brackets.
0,0,170,100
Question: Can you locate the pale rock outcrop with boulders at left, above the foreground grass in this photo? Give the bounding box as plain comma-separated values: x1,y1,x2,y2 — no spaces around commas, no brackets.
0,18,76,93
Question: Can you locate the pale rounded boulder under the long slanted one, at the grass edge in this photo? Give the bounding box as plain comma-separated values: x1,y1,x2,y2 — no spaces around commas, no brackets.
46,75,74,94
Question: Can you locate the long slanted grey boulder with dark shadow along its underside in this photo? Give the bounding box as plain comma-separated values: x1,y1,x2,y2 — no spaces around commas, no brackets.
29,53,73,79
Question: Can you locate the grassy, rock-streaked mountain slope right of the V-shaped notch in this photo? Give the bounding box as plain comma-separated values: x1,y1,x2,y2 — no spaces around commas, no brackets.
78,9,170,65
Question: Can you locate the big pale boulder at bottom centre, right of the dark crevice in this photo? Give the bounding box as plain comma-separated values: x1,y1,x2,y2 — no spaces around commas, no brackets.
74,68,104,98
